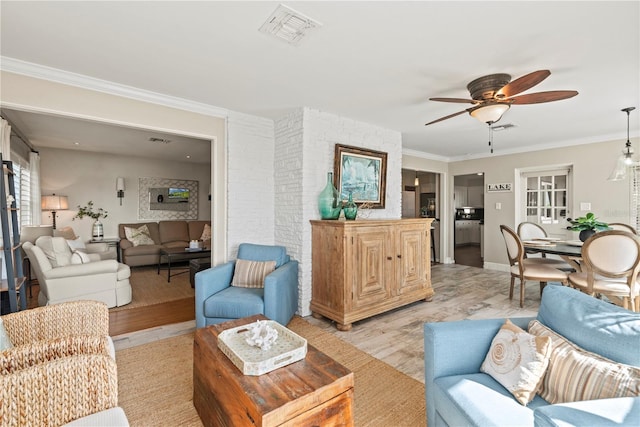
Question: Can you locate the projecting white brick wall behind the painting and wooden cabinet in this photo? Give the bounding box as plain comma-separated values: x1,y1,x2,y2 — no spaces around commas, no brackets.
275,108,402,316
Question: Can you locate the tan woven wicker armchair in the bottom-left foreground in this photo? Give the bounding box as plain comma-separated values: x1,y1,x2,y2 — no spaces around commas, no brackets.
0,301,127,426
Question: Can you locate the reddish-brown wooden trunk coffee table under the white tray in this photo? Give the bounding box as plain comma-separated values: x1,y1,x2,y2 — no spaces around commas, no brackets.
193,315,353,427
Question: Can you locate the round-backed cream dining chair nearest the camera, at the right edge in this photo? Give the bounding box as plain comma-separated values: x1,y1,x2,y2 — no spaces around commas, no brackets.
569,230,640,312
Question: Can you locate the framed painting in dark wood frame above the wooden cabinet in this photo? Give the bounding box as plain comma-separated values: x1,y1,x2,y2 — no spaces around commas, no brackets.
333,144,387,209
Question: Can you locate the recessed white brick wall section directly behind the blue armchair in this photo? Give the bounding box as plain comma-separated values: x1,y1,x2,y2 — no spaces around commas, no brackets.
227,112,275,259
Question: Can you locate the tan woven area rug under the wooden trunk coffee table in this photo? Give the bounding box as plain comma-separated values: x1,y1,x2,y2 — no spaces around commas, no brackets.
116,316,426,427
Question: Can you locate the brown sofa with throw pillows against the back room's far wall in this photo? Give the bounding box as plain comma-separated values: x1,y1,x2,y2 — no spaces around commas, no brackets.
118,220,211,267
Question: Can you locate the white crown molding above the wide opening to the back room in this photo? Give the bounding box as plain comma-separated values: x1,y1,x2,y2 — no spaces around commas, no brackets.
0,56,229,118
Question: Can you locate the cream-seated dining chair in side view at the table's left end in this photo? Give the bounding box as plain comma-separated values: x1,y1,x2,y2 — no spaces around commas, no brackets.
500,225,568,307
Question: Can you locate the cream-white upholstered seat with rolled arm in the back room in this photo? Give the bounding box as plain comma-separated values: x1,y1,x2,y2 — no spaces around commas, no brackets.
22,236,131,308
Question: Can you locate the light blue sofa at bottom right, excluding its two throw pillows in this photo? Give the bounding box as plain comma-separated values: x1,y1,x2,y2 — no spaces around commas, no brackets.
424,285,640,427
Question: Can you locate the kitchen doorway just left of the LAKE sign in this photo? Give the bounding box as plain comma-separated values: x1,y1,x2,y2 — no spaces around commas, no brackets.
453,172,484,268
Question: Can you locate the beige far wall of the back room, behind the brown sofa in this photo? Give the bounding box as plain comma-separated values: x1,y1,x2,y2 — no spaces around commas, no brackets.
39,148,211,241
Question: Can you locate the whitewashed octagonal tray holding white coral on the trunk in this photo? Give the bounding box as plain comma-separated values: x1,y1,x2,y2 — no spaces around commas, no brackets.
218,320,307,375
